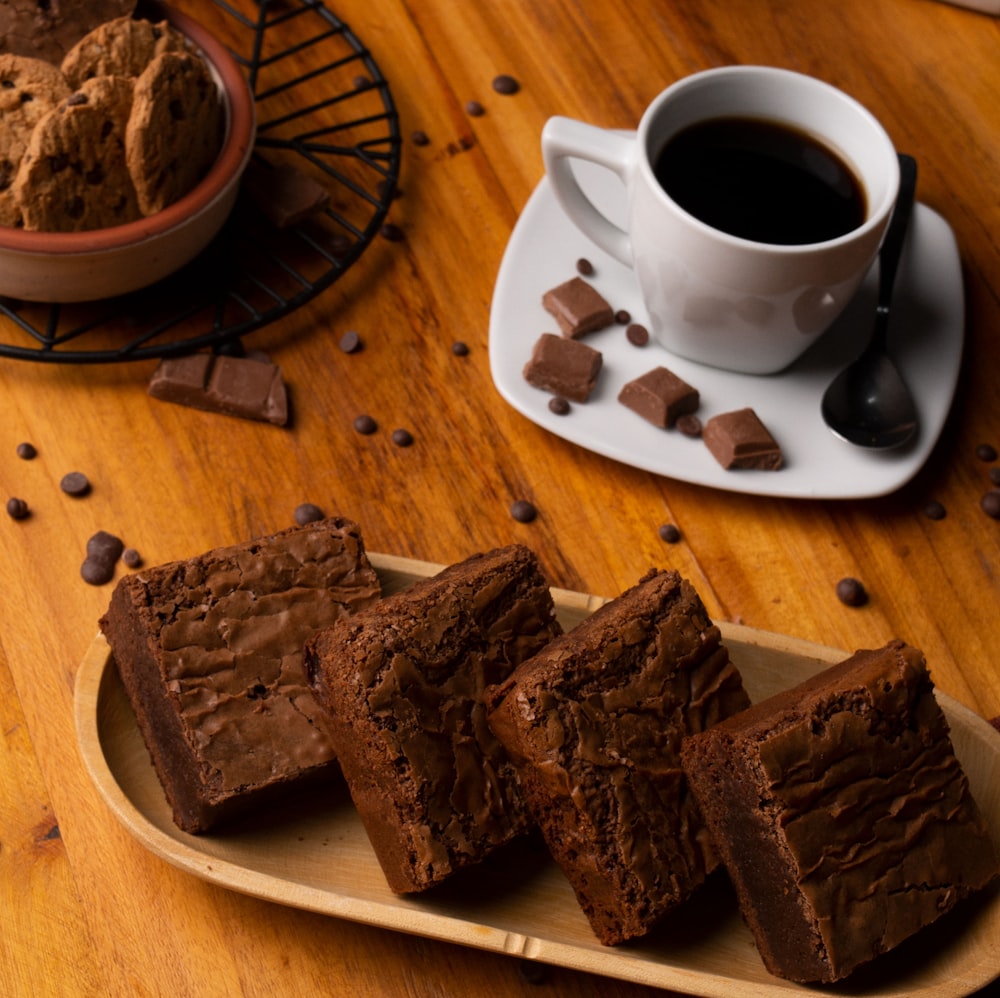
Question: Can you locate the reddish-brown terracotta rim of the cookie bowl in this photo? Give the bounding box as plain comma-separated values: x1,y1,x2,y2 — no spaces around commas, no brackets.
0,4,255,256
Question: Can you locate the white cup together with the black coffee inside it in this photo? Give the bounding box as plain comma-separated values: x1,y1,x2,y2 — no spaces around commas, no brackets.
542,66,899,374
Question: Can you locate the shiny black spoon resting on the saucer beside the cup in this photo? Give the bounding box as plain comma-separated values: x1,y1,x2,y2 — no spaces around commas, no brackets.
820,154,919,450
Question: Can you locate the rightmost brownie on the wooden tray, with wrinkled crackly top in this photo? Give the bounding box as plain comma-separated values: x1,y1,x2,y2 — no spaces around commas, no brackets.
681,641,997,983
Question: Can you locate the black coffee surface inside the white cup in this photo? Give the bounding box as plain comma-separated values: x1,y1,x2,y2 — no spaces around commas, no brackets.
653,118,867,245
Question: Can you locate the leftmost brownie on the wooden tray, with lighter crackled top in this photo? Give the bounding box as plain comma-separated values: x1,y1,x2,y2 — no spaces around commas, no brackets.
100,518,380,833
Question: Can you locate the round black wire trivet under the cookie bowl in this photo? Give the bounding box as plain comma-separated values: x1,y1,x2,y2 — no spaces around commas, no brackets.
0,0,401,363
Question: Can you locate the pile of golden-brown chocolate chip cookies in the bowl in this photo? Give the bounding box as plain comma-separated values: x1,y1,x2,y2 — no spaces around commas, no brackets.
0,15,225,232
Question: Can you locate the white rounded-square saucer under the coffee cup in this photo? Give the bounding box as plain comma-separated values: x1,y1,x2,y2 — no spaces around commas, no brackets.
490,162,965,499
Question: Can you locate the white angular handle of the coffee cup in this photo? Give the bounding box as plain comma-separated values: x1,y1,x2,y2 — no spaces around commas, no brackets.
542,117,635,267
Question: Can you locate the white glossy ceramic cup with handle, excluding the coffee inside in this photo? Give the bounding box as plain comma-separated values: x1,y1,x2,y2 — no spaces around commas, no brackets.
542,66,899,374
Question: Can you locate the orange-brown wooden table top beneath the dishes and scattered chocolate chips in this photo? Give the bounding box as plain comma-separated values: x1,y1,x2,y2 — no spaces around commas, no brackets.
0,0,1000,998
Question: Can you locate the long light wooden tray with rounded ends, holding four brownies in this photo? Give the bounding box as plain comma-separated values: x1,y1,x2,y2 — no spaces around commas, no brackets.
75,554,1000,998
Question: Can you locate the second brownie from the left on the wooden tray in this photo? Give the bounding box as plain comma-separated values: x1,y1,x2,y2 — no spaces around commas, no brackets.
306,545,562,894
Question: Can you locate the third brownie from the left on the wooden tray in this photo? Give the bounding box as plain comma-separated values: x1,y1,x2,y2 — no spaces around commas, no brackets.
487,570,749,945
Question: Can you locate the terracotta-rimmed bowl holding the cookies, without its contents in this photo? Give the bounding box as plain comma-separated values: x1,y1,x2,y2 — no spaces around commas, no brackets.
0,9,256,302
